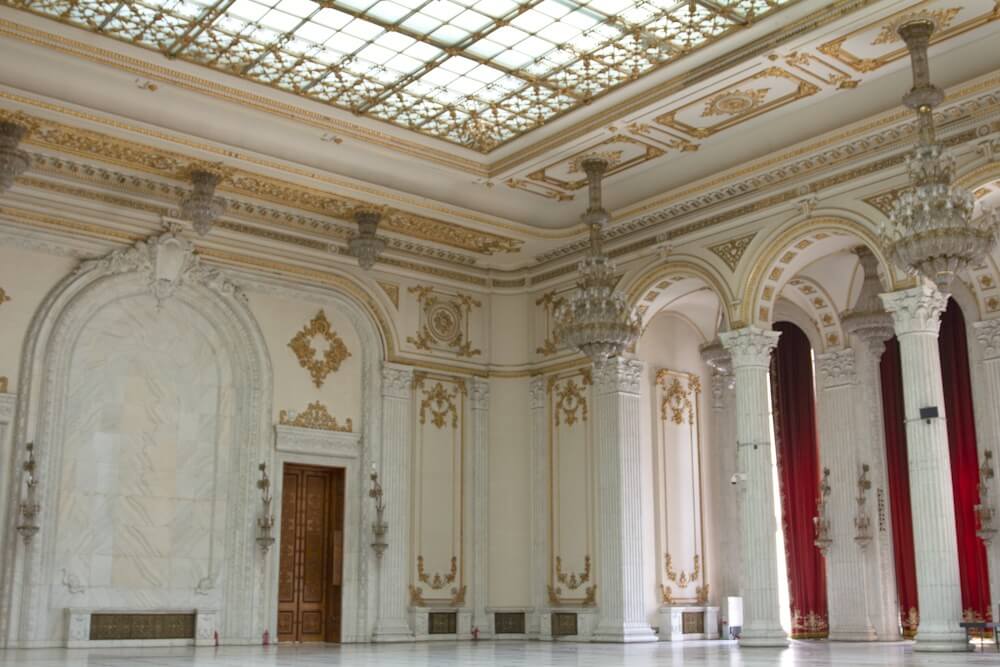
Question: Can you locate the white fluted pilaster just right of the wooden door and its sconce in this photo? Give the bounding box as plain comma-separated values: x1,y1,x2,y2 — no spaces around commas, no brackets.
372,363,413,642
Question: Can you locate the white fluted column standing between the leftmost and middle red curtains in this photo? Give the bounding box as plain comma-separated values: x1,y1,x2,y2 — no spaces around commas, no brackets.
816,349,875,641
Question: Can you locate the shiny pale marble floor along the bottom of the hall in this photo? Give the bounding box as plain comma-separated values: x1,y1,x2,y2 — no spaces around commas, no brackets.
0,641,1000,667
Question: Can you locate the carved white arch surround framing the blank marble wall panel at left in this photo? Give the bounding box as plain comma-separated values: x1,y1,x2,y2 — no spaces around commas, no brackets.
0,233,272,645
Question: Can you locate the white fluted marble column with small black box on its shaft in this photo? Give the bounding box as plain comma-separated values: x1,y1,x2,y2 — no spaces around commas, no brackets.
882,283,969,651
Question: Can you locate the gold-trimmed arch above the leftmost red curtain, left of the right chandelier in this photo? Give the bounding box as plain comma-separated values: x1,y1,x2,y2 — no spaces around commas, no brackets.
738,217,912,328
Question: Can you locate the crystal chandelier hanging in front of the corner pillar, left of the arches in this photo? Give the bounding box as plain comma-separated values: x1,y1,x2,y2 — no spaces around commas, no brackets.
555,157,639,365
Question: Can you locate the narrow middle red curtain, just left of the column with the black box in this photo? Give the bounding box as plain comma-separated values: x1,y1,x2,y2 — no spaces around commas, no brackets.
879,336,920,638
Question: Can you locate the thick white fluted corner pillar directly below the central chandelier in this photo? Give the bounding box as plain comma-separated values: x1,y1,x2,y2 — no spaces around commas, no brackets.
593,358,657,642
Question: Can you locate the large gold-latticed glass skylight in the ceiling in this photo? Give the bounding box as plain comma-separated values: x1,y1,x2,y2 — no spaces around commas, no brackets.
9,0,792,153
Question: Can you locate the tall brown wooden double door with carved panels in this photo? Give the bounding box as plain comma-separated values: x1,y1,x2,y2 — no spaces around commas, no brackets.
278,463,344,642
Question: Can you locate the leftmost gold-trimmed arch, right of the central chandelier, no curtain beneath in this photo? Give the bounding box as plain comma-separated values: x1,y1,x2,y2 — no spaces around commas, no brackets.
625,255,733,329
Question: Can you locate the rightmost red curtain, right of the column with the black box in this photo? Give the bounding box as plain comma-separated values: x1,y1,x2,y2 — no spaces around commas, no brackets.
938,299,992,621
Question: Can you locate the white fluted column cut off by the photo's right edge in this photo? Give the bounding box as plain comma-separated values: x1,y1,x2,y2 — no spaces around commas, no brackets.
972,319,1000,620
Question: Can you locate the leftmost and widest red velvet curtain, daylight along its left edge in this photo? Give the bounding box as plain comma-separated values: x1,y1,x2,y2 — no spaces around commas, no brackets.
771,322,828,639
